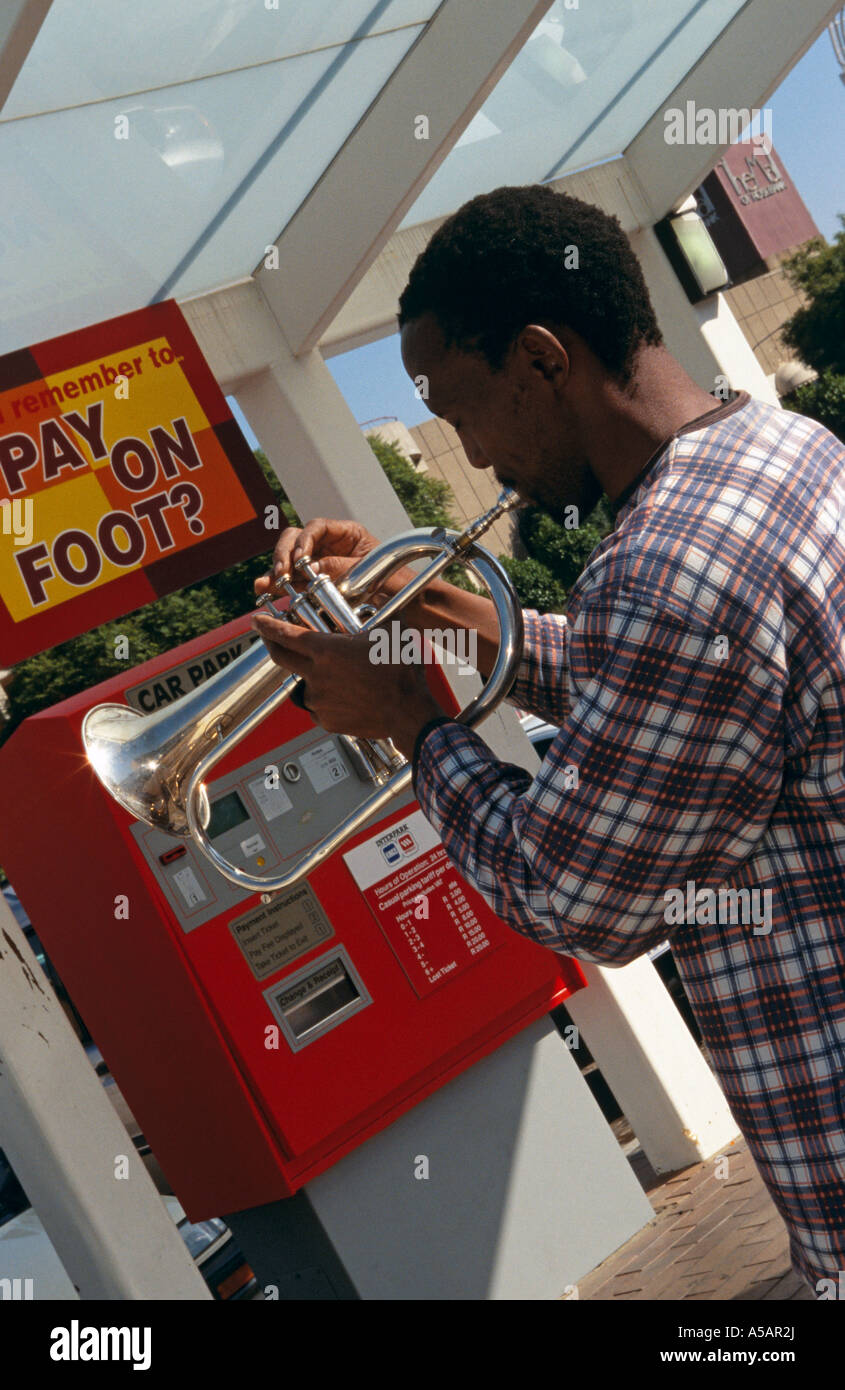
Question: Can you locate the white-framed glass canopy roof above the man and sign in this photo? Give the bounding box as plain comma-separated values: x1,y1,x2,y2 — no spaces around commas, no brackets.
0,0,827,352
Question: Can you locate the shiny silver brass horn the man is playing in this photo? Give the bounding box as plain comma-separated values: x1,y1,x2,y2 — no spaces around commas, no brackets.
82,488,523,898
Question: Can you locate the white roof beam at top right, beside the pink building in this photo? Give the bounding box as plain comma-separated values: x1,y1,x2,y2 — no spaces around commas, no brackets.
624,0,841,222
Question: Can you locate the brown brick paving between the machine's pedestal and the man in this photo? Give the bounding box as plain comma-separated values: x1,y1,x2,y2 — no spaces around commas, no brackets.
578,1120,814,1302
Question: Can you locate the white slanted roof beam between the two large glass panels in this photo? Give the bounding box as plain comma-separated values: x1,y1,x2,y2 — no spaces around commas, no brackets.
256,0,550,356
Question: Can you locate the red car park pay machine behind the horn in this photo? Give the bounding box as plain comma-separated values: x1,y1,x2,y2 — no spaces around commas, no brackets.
0,619,584,1219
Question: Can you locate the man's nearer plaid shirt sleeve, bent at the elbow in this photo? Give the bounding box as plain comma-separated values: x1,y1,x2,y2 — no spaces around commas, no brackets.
414,596,785,965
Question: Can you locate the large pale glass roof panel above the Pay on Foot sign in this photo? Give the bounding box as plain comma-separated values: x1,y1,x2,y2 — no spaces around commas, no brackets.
0,0,436,352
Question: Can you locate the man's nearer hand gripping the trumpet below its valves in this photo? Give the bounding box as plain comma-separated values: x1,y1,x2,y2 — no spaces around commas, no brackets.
252,613,443,759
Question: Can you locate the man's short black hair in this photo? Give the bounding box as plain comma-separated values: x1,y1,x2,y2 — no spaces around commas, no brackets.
399,183,663,382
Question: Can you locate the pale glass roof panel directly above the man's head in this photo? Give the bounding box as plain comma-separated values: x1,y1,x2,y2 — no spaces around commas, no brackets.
402,0,745,227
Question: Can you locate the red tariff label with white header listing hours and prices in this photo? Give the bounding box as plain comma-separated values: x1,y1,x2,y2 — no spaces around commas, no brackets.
343,810,498,998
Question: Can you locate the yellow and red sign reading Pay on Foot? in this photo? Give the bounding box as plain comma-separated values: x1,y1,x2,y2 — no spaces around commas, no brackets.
0,300,274,666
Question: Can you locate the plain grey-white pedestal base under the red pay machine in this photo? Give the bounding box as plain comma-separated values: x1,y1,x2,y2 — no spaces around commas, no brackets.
306,1019,653,1301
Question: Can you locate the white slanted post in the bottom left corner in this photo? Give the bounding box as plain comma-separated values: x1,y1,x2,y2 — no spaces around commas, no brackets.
0,895,211,1300
